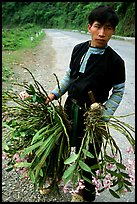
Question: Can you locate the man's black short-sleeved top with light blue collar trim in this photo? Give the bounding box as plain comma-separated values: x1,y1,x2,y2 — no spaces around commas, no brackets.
68,41,125,105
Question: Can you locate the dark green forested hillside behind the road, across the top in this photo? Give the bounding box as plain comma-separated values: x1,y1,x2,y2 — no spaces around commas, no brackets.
2,2,135,37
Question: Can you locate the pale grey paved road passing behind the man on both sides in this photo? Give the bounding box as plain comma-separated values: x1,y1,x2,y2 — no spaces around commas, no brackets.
44,29,135,202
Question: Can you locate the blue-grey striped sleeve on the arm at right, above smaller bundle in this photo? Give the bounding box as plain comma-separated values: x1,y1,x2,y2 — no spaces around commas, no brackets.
102,83,125,122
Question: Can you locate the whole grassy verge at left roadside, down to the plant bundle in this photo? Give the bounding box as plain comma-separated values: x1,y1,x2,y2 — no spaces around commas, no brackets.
2,23,45,82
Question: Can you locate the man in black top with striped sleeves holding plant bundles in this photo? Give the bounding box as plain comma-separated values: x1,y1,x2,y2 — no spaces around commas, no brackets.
20,6,125,202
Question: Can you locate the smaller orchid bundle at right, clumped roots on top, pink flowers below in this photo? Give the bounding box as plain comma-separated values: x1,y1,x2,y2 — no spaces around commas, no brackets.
62,106,135,198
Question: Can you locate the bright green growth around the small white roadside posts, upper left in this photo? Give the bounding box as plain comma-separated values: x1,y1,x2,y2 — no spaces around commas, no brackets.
2,24,44,50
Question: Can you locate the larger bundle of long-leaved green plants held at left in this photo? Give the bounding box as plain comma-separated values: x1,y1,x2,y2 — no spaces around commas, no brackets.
2,69,70,190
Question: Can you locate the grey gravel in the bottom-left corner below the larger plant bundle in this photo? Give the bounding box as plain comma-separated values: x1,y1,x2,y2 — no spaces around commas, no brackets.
2,160,71,202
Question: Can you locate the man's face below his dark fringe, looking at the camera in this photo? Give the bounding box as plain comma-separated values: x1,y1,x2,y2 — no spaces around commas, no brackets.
88,21,115,48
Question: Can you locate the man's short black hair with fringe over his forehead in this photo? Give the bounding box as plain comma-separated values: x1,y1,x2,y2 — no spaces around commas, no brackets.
88,6,119,28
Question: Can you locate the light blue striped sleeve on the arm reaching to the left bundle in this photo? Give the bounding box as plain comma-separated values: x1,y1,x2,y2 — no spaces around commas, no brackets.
51,68,70,98
